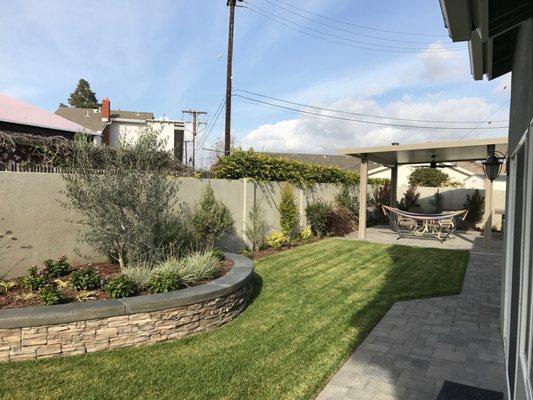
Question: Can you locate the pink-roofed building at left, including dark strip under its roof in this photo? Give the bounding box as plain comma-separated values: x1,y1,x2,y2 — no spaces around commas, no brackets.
0,94,97,139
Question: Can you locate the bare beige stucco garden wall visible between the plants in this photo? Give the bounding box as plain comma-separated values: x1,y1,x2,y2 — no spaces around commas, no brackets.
0,172,338,279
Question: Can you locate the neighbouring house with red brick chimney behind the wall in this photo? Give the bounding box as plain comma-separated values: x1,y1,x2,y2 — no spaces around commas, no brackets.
56,99,185,161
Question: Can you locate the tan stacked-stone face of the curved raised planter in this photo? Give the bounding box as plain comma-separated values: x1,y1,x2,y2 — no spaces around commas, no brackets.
0,256,252,362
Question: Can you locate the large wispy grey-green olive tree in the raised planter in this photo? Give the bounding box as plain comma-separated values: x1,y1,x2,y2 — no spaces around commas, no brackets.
63,129,180,267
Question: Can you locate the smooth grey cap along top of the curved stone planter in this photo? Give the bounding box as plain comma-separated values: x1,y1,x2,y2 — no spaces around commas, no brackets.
0,253,253,329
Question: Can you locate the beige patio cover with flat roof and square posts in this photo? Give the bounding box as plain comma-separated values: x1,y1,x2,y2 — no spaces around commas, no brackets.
338,138,507,246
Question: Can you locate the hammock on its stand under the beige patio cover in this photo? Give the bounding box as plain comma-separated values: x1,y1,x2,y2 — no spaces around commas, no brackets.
381,205,468,242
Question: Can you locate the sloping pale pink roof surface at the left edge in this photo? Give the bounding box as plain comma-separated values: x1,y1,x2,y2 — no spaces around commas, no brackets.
0,93,94,134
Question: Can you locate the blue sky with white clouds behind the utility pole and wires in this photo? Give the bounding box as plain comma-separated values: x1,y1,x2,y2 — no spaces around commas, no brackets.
0,0,510,166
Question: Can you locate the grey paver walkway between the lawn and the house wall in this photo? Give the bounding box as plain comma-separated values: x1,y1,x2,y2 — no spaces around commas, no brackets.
317,252,506,400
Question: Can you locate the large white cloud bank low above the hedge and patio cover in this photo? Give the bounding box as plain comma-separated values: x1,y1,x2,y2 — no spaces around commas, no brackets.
238,96,506,153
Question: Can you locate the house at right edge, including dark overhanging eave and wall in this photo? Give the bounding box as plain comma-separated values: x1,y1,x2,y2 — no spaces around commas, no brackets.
441,0,533,400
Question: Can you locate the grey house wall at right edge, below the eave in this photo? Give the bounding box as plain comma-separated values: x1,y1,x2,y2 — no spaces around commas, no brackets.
502,18,533,400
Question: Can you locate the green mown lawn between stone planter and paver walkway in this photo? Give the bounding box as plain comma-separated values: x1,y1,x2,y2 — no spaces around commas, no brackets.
0,239,468,400
